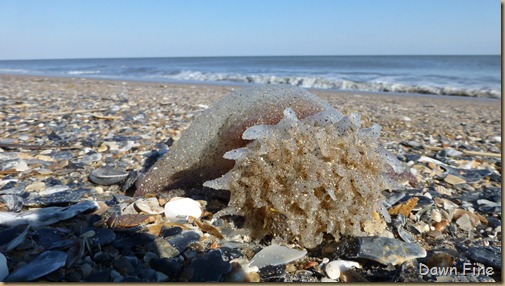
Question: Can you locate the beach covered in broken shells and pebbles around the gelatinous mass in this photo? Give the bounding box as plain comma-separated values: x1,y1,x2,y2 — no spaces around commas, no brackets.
0,75,502,282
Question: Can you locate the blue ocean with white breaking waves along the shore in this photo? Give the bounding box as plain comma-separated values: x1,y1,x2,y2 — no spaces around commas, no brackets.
0,55,501,98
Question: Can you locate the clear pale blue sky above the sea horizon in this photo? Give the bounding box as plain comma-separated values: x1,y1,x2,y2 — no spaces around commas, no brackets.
0,0,501,59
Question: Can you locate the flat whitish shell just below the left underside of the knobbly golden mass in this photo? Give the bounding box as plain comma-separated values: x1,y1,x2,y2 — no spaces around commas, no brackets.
251,244,307,268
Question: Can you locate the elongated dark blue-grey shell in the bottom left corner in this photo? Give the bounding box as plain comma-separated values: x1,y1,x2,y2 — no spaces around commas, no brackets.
5,250,67,282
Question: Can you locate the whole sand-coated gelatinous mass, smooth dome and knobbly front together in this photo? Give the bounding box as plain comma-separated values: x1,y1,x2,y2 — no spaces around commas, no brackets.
135,85,408,248
